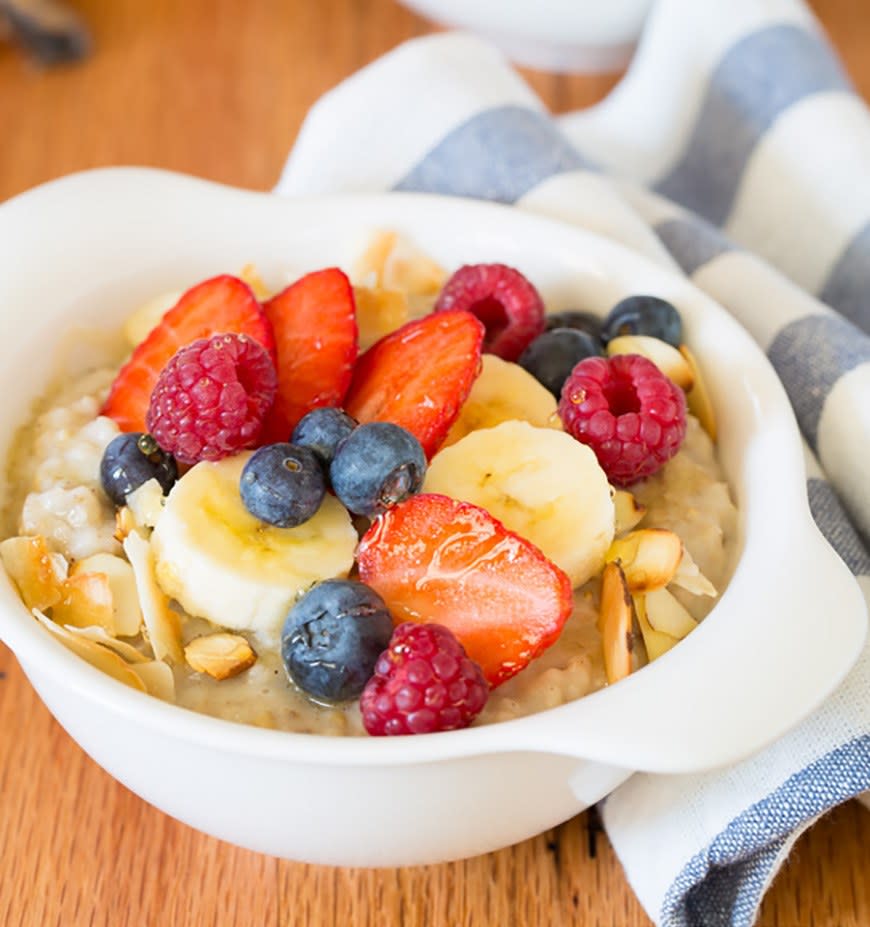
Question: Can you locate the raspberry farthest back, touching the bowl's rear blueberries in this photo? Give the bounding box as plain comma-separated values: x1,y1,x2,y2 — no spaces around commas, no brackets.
435,264,544,361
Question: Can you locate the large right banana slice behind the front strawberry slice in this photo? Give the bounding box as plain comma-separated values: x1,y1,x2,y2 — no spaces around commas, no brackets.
424,421,615,586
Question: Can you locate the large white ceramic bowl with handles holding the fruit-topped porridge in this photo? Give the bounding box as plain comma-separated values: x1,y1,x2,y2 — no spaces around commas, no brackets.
0,169,865,866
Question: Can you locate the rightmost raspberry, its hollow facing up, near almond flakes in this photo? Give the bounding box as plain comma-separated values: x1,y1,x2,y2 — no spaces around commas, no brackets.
559,354,686,486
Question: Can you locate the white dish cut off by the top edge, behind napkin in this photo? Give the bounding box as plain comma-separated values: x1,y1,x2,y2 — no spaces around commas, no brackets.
401,0,652,72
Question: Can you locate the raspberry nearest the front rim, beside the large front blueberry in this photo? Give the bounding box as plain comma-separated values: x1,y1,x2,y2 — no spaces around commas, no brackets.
360,621,489,736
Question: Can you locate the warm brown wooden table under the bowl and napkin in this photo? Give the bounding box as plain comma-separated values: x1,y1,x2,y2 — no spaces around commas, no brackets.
0,0,870,927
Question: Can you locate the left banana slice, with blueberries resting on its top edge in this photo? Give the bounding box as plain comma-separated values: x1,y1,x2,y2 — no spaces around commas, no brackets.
151,453,357,633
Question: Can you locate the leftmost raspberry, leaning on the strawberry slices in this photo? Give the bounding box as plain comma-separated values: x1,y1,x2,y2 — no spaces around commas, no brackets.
147,333,277,464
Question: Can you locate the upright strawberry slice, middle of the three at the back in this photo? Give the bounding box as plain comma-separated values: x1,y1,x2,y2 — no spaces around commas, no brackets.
263,267,357,443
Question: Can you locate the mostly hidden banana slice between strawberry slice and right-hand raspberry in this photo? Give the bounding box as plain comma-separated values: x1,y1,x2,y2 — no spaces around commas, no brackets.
442,354,562,448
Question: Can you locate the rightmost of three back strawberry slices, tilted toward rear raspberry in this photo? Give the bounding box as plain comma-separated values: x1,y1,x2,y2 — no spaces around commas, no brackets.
345,311,484,457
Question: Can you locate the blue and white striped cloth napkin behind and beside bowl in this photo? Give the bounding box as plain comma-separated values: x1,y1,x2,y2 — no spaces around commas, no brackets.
278,0,870,927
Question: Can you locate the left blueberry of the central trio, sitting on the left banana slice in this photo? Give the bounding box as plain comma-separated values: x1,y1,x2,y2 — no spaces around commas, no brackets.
239,444,326,528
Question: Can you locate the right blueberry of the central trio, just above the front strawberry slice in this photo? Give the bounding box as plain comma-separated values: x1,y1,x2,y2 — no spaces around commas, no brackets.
329,422,426,517
